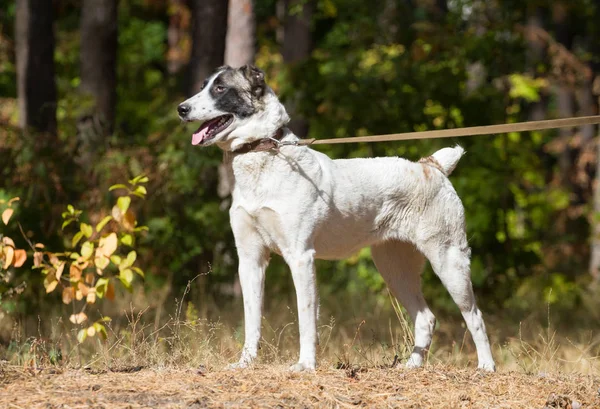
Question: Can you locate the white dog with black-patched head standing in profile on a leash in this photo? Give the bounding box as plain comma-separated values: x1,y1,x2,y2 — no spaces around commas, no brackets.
177,65,496,371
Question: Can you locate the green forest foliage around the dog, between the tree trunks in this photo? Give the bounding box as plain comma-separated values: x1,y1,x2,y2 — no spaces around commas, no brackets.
0,0,600,339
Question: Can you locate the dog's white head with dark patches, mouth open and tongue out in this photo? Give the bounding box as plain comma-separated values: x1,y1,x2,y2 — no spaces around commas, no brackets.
177,65,289,150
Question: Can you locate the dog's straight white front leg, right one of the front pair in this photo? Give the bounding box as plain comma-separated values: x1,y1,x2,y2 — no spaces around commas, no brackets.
286,250,318,372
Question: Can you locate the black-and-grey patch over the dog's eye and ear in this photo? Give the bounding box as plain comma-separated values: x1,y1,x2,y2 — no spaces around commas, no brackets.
208,65,266,118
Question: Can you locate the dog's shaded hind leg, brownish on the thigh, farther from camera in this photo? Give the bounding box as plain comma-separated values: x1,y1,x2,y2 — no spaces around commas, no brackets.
371,241,435,368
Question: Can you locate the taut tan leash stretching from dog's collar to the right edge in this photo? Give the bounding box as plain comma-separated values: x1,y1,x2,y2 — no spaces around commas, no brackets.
298,115,600,145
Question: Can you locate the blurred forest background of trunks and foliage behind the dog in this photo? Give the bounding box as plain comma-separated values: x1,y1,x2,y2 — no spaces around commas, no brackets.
0,0,600,368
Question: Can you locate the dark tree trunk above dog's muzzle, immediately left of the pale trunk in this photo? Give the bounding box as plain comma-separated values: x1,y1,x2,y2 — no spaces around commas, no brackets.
190,0,228,94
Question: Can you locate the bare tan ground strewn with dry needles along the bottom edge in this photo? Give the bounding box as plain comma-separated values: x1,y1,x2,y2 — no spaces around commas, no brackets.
0,366,600,409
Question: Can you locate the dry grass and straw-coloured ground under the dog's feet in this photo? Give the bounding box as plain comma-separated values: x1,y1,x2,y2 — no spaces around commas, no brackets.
0,288,600,409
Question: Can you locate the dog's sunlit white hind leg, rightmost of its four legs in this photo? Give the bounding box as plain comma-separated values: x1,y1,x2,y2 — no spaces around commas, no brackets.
423,244,496,372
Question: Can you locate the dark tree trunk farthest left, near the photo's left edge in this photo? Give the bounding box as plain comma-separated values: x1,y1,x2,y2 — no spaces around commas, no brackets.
15,0,56,135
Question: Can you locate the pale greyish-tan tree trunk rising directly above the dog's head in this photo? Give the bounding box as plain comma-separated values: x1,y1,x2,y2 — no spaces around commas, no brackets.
225,0,256,68
